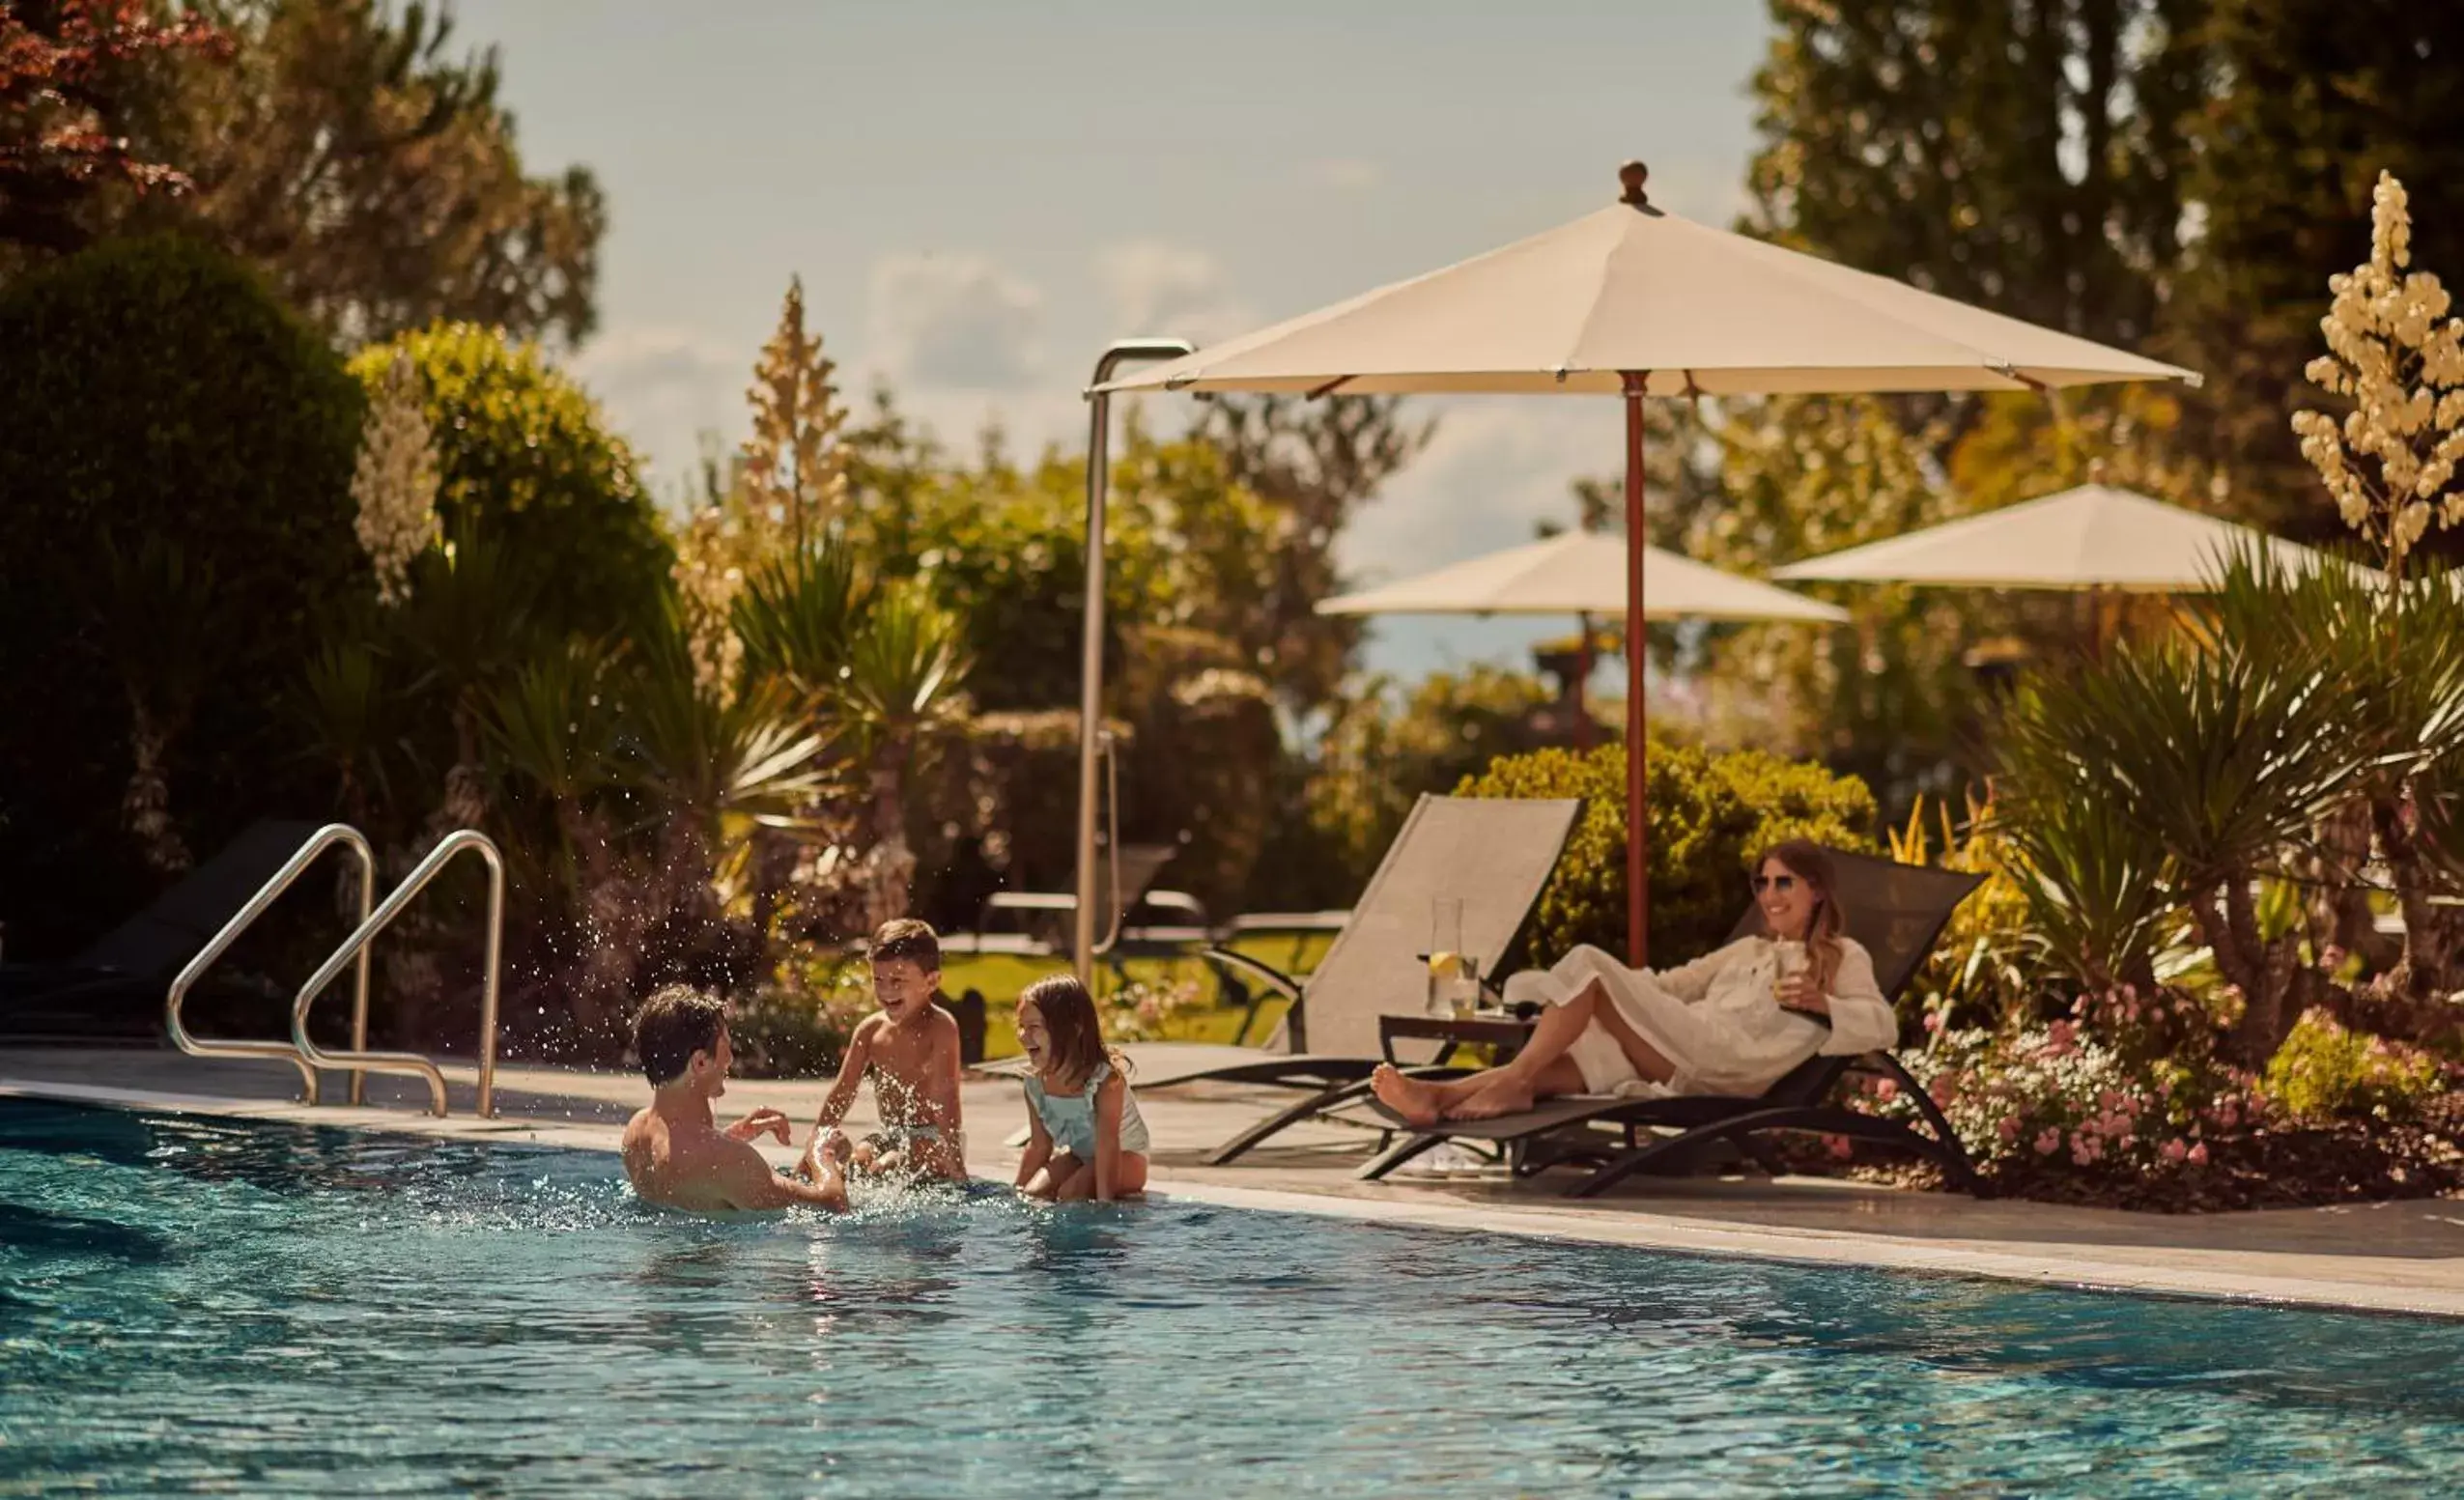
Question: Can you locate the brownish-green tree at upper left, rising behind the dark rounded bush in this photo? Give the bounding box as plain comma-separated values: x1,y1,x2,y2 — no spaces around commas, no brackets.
32,0,607,348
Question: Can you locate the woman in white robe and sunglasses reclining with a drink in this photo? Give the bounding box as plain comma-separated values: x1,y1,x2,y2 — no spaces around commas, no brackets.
1370,840,1900,1125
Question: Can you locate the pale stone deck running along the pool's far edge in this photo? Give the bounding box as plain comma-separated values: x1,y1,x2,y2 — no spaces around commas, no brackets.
0,1047,2464,1317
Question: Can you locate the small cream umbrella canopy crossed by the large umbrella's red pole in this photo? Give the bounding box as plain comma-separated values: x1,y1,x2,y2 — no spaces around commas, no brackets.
1318,532,1848,623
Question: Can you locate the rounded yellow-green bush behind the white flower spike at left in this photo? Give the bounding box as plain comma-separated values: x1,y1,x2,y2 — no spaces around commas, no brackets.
350,323,672,636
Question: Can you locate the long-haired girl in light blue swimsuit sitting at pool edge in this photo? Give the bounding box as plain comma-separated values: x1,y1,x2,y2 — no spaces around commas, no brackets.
1018,976,1146,1202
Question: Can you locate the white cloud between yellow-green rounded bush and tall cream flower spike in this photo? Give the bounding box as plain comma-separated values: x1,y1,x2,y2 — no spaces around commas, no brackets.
569,325,754,500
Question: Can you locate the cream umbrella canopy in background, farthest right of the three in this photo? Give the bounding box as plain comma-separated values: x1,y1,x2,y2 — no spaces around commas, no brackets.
1774,485,2331,594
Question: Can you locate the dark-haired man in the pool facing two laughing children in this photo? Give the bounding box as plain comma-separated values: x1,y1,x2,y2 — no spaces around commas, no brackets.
623,985,848,1214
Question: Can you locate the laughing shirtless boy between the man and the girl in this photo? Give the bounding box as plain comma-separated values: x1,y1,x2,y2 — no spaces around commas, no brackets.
813,917,966,1179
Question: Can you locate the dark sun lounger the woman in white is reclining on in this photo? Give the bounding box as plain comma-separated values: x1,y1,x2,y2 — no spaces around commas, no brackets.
1355,850,1984,1197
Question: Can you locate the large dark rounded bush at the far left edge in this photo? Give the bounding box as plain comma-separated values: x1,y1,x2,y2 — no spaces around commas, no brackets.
0,239,370,958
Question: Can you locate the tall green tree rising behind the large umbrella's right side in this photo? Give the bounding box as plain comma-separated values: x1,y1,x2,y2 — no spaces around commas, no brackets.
1747,0,2207,342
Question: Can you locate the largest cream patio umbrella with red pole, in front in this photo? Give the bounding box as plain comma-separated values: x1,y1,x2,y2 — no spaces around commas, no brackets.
1079,162,2193,963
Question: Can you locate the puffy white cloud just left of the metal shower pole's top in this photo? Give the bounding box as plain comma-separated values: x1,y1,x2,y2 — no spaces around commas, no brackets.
872,251,1045,391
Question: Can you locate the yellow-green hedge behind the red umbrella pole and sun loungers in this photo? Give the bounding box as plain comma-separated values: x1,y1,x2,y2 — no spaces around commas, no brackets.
1457,744,1875,966
